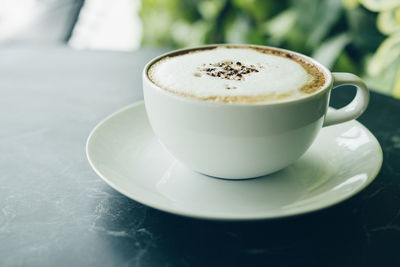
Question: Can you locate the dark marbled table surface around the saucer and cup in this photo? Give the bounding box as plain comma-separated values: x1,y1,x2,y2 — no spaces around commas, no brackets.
0,46,400,267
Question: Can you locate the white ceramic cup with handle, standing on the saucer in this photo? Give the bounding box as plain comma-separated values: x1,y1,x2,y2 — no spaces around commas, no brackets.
143,45,369,179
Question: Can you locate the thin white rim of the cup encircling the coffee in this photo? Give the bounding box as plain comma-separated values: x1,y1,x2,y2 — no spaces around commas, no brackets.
143,43,333,107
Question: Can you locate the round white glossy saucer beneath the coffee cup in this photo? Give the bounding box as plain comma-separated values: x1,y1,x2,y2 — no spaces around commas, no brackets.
86,102,382,220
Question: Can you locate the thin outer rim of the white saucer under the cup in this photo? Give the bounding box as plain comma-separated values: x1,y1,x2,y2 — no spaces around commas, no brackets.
85,100,383,221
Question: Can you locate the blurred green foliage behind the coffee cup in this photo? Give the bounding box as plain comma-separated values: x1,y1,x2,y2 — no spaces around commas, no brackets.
140,0,400,97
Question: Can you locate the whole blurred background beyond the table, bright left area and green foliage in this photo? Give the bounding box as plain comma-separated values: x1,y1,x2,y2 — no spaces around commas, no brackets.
0,0,400,98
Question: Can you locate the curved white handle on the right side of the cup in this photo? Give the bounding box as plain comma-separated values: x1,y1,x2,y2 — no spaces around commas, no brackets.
323,72,369,127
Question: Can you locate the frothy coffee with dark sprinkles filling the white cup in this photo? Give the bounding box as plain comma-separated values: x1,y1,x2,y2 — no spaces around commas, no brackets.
148,45,326,103
